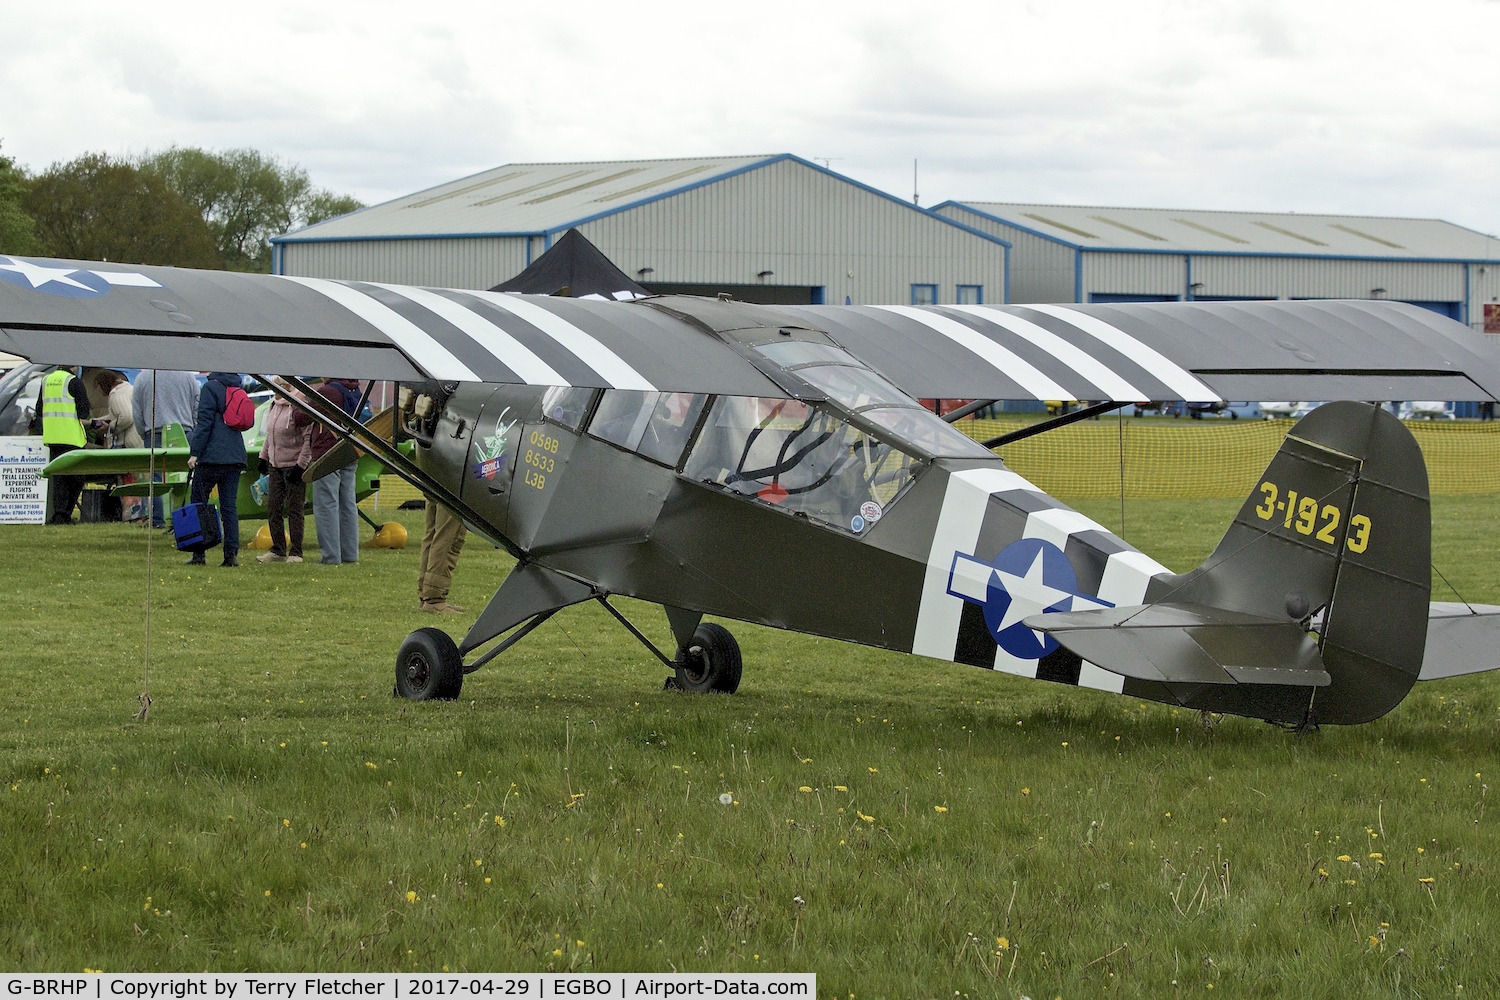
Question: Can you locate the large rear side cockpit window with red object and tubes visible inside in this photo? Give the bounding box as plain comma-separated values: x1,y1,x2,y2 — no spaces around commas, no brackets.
683,396,918,534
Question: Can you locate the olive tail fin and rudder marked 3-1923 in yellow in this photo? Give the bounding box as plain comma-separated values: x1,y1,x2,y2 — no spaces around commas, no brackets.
1170,402,1433,724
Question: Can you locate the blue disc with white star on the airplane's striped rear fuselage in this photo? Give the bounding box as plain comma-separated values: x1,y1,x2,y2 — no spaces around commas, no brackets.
984,538,1079,660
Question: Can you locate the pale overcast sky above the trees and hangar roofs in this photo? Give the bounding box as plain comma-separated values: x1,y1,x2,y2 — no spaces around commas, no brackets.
0,0,1500,232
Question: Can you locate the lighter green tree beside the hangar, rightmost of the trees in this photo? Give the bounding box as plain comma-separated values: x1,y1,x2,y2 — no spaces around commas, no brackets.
140,145,363,271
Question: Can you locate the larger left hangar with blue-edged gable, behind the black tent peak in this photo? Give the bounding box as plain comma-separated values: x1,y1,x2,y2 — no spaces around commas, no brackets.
272,154,1010,304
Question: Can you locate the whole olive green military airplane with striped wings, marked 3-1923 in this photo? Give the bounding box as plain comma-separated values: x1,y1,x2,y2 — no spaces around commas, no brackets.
0,251,1500,726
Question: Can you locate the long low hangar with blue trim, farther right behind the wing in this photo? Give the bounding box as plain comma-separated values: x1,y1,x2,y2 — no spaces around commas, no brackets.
933,201,1500,330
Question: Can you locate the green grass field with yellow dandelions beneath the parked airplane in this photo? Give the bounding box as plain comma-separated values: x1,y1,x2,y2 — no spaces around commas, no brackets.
0,496,1500,999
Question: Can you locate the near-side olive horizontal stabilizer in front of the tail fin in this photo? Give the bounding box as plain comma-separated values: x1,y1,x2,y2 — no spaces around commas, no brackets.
1026,604,1331,687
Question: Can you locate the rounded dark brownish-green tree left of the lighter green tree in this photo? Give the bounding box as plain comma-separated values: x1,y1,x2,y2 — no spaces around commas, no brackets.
21,153,224,267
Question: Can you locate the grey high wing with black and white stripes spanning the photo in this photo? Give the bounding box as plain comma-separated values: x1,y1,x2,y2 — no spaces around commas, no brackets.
0,256,1500,402
